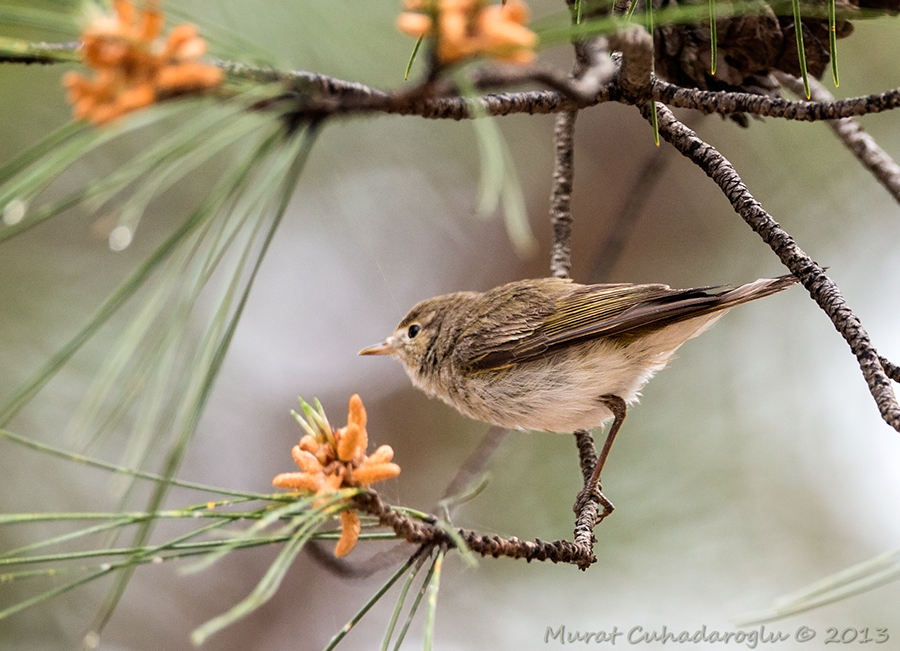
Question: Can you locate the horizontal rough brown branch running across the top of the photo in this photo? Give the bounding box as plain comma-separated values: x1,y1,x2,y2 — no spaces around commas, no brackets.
3,39,900,121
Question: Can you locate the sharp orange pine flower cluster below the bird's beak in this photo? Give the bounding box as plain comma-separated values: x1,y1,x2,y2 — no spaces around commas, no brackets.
272,394,400,556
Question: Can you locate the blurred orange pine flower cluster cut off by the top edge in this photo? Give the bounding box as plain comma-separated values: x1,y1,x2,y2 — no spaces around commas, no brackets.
397,0,538,64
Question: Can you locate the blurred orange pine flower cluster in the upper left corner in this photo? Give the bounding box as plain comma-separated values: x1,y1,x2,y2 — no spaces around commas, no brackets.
63,0,224,124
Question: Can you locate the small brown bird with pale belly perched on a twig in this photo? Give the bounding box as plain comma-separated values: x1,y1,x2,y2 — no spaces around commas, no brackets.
360,276,797,510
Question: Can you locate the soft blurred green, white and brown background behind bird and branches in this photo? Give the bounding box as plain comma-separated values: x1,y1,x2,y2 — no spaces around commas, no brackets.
0,0,900,651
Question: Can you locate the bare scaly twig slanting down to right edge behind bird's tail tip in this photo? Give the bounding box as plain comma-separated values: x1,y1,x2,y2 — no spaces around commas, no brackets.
641,105,900,431
